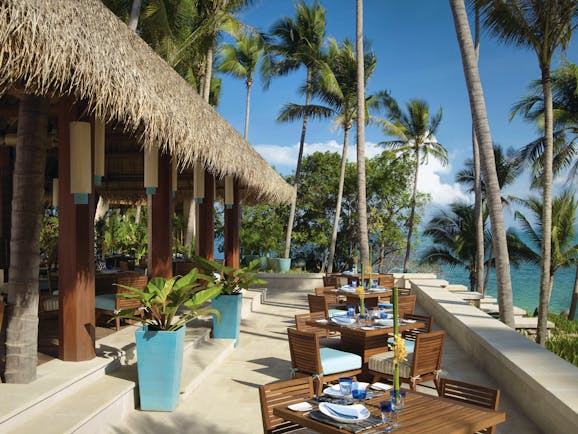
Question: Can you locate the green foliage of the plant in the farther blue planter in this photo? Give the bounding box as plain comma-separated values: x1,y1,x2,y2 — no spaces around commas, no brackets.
195,257,265,295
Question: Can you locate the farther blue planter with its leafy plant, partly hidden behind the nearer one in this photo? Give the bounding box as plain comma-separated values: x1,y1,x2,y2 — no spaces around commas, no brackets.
195,258,265,347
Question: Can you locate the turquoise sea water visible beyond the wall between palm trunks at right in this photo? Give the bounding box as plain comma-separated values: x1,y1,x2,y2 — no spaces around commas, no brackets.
438,264,576,315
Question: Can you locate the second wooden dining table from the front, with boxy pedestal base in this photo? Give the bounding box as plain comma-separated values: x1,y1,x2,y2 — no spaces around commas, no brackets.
306,318,425,365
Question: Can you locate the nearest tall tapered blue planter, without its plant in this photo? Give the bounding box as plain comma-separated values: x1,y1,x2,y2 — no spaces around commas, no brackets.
135,326,186,411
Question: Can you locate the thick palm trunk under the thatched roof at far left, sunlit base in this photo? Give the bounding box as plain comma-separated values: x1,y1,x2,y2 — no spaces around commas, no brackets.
4,95,49,383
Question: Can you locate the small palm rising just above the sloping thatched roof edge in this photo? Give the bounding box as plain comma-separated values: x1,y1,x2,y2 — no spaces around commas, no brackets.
218,32,263,139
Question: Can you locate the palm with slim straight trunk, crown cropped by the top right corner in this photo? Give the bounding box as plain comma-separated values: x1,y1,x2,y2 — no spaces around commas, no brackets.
477,0,577,345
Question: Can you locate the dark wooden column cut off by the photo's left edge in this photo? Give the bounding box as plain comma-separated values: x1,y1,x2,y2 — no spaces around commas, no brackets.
0,146,14,284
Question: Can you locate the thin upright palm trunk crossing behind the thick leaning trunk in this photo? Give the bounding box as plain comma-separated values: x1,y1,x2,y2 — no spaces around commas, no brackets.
470,8,485,293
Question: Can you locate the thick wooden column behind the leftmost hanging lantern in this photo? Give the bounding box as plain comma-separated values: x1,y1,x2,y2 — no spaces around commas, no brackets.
58,100,95,361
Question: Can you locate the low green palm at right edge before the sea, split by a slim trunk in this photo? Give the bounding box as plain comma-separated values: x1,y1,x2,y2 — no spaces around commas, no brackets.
514,191,578,302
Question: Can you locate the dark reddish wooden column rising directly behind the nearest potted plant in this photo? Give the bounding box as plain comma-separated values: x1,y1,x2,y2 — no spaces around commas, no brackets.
147,151,173,279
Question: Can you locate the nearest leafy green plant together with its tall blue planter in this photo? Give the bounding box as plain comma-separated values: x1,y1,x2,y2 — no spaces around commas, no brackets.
117,268,221,411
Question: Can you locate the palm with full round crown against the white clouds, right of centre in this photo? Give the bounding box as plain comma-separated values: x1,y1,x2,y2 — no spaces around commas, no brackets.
380,99,448,273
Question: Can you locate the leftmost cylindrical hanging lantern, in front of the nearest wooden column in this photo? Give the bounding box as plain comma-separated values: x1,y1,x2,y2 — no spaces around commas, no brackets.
70,121,92,205
